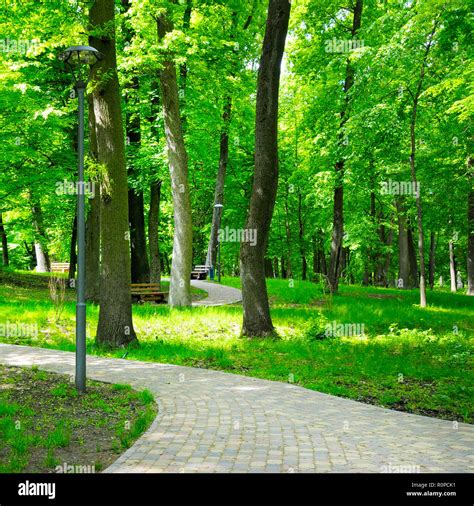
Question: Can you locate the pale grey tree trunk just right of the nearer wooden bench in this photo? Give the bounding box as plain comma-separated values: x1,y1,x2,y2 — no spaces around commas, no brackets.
157,9,193,306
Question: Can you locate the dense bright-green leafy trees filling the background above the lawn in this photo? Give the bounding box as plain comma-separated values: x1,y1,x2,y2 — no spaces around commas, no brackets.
0,0,474,344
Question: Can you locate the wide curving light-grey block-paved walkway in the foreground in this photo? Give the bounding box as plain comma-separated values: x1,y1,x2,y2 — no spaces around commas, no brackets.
0,344,474,473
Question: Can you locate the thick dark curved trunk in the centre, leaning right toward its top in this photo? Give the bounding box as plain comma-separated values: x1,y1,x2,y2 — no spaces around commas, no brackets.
240,0,290,336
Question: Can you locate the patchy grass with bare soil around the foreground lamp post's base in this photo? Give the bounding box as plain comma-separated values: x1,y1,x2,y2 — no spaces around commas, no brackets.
0,365,157,473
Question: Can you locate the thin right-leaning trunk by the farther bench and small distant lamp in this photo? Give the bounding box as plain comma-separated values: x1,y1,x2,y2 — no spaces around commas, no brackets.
206,97,232,266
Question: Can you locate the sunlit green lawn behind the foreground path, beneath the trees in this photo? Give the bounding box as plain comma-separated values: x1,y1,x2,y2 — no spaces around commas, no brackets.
0,270,474,423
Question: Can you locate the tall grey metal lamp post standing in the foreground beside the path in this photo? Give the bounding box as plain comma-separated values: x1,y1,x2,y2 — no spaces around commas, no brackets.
59,46,102,393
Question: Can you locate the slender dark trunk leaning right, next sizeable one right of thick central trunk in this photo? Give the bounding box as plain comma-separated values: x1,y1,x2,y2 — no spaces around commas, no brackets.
328,0,363,293
